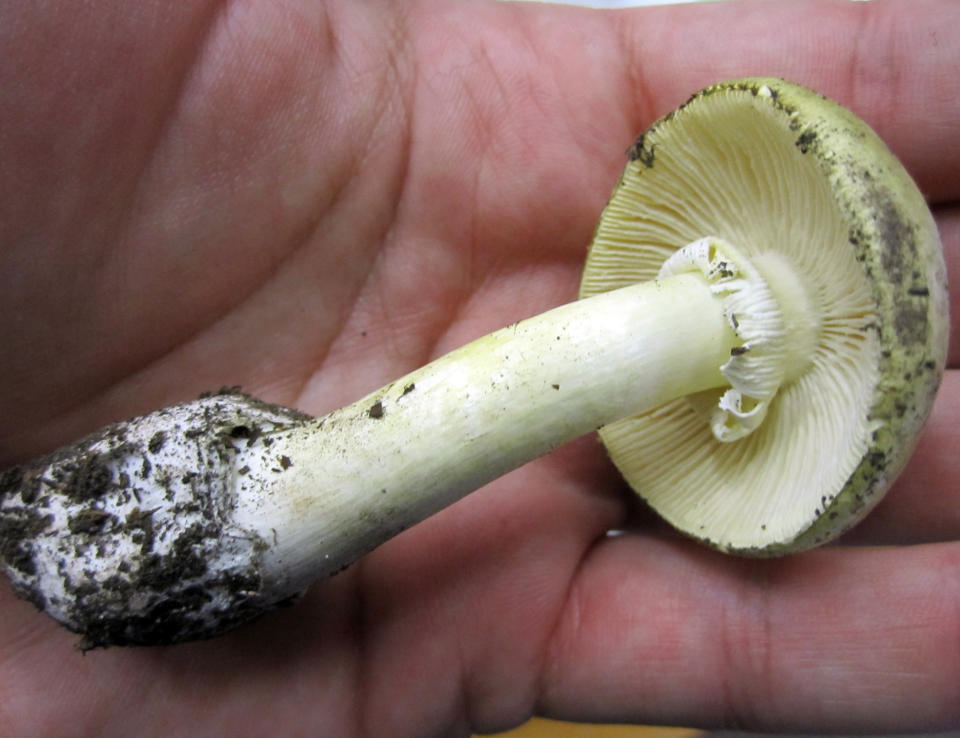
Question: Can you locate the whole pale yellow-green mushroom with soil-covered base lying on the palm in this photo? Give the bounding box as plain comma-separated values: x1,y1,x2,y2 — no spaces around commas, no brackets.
0,79,948,647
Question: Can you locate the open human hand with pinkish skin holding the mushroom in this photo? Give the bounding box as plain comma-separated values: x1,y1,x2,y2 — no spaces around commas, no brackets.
0,0,960,736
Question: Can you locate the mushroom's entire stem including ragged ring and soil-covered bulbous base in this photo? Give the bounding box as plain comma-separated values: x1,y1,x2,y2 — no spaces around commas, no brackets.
0,238,802,645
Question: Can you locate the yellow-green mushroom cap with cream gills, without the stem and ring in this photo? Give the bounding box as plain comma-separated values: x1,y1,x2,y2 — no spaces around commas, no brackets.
581,78,949,556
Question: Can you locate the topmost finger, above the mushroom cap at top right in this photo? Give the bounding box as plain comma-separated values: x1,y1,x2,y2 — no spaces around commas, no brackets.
615,0,960,201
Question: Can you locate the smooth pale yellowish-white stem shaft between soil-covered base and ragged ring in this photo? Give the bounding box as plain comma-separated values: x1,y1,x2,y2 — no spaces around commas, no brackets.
237,274,738,587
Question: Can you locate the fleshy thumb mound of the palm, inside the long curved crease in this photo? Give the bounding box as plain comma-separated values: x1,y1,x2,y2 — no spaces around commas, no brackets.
0,1,404,464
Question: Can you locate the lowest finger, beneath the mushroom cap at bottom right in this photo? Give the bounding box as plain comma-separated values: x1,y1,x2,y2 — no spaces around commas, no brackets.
539,536,960,733
